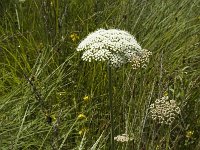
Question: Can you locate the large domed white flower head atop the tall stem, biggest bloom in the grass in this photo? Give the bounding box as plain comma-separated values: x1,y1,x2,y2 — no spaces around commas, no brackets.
77,29,152,67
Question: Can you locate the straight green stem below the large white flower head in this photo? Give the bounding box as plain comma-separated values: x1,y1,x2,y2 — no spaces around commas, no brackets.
108,65,114,150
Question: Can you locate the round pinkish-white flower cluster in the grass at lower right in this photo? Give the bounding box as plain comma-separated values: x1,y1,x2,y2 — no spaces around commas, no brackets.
150,96,180,125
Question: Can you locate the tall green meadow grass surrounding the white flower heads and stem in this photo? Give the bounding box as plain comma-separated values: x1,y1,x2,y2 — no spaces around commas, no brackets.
0,0,200,150
